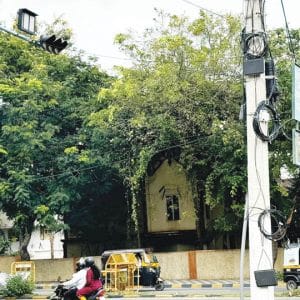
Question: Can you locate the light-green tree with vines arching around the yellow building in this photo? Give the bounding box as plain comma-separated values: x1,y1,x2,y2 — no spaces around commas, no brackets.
89,12,246,247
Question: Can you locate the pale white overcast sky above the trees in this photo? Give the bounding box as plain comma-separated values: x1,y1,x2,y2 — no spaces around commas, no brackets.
0,0,300,72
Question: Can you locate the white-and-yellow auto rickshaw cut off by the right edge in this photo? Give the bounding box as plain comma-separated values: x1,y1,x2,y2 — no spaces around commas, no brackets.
283,243,300,291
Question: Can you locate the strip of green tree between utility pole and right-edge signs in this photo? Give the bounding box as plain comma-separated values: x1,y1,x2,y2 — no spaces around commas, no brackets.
269,28,300,242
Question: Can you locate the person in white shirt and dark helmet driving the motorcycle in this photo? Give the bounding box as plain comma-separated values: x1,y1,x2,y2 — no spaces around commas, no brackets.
62,257,88,300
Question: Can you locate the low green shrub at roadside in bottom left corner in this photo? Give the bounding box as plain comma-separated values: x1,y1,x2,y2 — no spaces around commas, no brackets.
1,275,34,297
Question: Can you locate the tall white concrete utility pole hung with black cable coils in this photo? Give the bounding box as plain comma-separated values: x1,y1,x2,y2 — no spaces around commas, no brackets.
244,0,274,300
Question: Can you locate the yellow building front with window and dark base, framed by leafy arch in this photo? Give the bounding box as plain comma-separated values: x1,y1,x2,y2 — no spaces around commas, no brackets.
145,159,197,251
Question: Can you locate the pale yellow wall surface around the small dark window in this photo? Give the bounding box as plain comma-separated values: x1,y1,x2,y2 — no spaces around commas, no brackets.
146,160,196,232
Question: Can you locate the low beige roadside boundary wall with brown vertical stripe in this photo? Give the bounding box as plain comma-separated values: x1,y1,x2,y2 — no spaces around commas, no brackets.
0,249,283,282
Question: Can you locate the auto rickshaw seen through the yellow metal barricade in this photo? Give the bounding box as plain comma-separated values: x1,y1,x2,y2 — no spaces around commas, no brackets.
101,249,165,291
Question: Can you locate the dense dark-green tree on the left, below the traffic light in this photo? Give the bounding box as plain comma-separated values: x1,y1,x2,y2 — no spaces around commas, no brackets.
0,29,110,259
